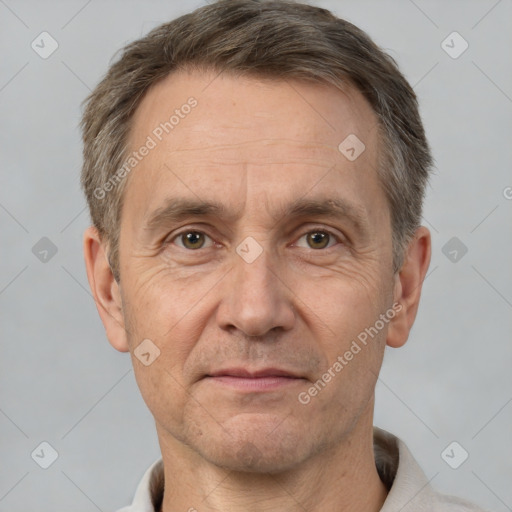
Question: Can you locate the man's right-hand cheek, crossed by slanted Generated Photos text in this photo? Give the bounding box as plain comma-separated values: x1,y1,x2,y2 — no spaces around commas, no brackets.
297,264,392,400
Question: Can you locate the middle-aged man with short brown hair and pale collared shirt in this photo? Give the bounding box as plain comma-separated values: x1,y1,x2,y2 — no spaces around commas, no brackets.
82,0,488,512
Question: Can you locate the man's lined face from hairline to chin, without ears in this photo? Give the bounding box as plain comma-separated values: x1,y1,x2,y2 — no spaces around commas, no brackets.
120,72,395,471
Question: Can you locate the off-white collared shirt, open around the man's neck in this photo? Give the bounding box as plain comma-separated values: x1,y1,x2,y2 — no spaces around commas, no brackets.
117,427,484,512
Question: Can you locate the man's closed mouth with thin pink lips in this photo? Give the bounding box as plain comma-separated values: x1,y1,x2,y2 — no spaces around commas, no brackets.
205,368,305,392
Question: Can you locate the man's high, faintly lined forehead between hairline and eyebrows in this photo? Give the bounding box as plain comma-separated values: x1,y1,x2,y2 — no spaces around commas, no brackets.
125,71,384,220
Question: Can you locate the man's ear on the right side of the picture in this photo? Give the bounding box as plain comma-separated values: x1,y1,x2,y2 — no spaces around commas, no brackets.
386,226,432,348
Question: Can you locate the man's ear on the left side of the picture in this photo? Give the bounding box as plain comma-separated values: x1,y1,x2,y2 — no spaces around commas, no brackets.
83,226,129,352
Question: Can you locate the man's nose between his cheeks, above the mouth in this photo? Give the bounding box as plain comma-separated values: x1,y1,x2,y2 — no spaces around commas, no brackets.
217,242,295,337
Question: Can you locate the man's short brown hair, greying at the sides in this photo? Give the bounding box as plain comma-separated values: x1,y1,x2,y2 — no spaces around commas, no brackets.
81,0,432,279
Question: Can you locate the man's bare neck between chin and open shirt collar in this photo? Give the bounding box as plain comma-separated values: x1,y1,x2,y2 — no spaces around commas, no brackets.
157,404,387,512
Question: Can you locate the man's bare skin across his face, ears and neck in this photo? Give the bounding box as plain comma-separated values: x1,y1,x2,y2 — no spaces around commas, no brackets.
84,71,430,512
